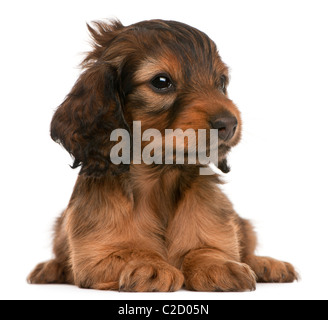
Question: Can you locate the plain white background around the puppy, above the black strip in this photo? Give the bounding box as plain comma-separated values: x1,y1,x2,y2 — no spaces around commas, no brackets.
0,0,328,300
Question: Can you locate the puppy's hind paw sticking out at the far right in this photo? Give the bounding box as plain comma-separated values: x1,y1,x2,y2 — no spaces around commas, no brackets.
245,256,299,283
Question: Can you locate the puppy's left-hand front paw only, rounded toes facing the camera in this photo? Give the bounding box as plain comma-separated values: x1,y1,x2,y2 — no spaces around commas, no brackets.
119,261,184,292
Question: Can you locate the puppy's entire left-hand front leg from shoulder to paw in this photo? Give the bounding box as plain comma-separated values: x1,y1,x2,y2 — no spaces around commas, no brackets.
64,182,184,292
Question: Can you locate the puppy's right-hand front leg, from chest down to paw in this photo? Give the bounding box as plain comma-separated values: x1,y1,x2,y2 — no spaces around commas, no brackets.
167,178,256,291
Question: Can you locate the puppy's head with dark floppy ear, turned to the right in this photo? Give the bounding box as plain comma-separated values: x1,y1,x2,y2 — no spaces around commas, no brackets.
51,20,241,176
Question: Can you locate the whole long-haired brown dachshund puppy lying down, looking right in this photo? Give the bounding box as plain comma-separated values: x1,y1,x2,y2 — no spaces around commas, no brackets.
28,20,297,292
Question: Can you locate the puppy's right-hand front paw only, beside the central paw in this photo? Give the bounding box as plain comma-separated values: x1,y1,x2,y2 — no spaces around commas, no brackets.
185,261,256,292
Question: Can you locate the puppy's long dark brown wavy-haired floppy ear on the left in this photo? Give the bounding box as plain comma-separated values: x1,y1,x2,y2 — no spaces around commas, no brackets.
51,60,128,177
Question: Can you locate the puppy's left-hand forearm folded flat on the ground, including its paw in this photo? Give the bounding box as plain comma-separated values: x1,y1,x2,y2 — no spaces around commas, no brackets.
69,247,184,292
